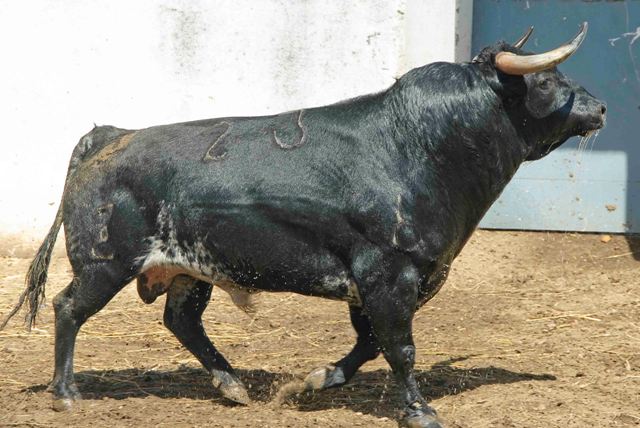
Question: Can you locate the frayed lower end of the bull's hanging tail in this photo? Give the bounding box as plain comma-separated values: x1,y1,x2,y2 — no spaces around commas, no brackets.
0,203,62,330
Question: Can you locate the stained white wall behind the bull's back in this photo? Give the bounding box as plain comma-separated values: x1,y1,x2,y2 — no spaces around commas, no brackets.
0,0,471,255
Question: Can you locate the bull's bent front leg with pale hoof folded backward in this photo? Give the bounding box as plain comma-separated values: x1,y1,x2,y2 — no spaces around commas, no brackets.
304,306,380,391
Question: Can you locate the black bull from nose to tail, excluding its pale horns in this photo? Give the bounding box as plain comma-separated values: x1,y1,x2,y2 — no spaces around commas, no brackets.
3,25,605,426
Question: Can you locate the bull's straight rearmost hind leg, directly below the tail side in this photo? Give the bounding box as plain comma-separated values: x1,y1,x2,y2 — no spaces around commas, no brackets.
50,263,126,411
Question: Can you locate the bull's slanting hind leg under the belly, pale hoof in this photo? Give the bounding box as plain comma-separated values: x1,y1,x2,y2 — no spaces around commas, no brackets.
164,275,250,404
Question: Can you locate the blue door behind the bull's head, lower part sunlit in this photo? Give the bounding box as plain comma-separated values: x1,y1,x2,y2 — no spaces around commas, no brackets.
472,0,640,233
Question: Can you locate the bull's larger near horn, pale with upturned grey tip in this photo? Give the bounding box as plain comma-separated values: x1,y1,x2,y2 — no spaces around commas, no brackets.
496,22,589,76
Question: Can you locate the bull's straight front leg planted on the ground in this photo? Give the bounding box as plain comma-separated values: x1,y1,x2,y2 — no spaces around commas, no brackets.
354,250,442,428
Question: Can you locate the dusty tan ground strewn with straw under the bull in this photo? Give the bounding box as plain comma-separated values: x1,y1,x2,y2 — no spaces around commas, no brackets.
0,231,640,427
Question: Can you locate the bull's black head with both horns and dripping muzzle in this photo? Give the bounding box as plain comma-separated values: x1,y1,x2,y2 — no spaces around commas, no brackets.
474,22,607,160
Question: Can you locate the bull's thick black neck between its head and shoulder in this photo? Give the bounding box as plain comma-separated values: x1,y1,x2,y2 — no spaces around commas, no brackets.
390,64,528,240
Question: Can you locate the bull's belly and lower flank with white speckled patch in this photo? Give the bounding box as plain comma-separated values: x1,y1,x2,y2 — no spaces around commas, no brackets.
132,203,360,305
